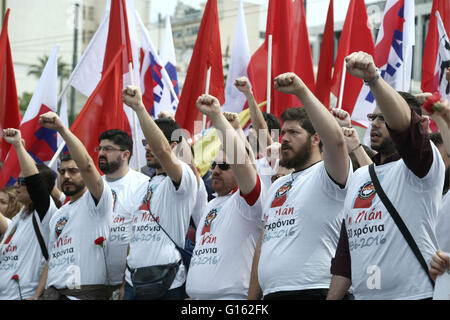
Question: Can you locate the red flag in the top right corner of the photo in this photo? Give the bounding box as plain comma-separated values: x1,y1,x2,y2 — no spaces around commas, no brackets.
421,0,450,92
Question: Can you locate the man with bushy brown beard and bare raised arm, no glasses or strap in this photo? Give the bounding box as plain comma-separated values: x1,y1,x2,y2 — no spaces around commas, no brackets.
248,73,352,299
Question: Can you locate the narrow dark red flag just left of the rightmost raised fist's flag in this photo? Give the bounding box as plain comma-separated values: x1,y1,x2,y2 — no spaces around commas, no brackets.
315,0,334,107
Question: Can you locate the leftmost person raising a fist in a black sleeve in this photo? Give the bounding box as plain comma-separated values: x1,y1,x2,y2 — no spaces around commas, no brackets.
0,128,57,300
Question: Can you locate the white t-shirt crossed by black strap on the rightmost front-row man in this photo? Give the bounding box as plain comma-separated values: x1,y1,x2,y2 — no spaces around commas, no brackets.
344,144,444,300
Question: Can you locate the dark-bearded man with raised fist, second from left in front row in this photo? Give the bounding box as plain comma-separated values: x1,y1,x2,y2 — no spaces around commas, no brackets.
39,112,113,300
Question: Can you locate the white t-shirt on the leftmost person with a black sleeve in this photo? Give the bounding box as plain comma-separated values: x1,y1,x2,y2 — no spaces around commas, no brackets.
0,199,57,300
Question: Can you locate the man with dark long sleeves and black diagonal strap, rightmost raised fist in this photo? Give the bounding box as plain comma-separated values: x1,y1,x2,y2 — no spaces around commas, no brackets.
328,52,444,300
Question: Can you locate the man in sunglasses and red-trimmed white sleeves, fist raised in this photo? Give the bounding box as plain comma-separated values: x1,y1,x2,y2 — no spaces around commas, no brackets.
186,100,262,299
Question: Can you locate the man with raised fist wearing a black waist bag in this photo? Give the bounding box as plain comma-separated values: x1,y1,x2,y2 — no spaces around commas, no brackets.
122,86,198,300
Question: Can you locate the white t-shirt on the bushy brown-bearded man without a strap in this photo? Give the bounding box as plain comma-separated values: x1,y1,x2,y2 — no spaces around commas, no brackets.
258,161,352,295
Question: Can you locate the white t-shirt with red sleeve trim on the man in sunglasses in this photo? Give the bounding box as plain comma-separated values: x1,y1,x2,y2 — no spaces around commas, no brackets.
186,176,262,300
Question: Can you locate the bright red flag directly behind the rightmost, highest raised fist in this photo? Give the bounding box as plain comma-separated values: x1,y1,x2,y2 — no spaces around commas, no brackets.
331,0,375,115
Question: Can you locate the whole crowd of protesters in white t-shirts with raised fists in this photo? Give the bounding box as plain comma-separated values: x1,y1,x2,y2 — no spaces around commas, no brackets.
0,52,450,300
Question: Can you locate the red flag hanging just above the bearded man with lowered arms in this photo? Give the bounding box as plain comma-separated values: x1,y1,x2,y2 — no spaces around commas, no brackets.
70,46,126,169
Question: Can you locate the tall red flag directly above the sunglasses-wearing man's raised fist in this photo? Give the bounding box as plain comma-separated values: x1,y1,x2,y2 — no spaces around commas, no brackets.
175,0,225,133
